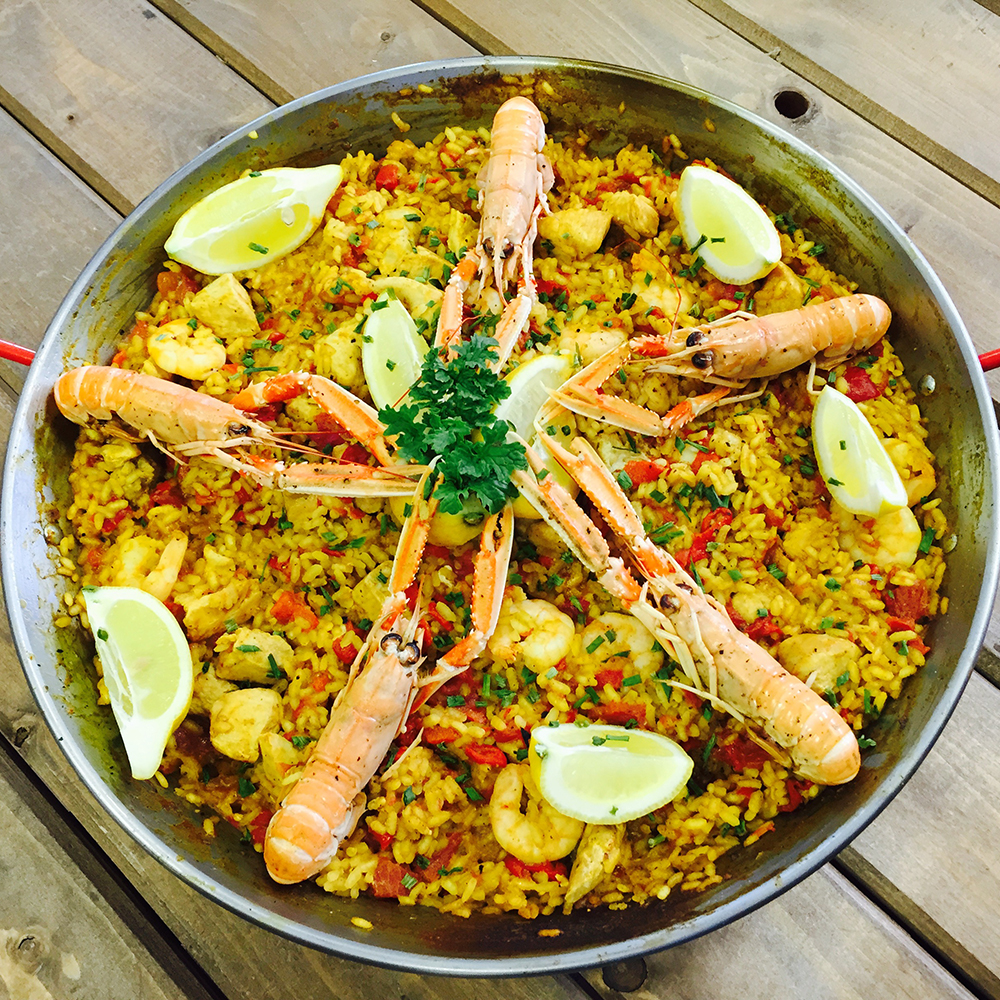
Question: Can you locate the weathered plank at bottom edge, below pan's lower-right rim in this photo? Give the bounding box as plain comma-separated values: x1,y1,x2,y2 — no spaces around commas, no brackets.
587,866,972,1000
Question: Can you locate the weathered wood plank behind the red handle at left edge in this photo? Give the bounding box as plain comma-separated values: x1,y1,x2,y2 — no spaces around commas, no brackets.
0,111,121,388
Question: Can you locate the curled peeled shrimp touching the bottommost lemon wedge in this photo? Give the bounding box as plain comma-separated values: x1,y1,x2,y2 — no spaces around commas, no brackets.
489,764,584,865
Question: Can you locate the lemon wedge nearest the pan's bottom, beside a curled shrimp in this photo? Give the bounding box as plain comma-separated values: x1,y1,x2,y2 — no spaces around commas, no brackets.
528,723,694,824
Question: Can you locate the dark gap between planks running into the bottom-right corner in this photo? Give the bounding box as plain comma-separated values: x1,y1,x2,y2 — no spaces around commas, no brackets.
831,847,1000,1000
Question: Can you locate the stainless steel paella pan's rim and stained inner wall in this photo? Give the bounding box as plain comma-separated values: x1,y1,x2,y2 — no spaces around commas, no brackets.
0,58,998,976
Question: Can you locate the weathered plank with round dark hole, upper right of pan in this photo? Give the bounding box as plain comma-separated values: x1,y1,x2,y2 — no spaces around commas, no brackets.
434,0,1000,396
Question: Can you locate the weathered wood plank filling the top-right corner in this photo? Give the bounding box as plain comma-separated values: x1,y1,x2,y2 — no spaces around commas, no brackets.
716,0,1000,188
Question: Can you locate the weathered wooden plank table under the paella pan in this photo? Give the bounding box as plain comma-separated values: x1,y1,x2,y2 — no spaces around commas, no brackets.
0,0,1000,1000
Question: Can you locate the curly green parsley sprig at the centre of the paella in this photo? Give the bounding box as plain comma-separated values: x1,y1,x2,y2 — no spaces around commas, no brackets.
378,334,528,514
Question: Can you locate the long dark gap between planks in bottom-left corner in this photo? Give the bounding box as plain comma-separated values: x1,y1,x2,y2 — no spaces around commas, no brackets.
0,733,226,1000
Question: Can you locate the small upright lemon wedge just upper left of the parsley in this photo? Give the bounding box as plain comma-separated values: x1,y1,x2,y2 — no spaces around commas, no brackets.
361,292,430,409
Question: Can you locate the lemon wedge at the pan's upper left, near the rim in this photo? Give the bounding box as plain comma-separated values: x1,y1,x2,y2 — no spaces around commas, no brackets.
163,163,343,274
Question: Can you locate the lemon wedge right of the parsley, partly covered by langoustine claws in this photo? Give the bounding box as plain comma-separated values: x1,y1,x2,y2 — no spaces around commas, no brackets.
494,354,578,520
